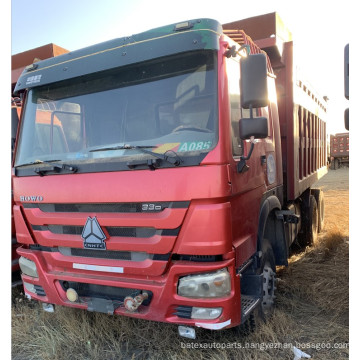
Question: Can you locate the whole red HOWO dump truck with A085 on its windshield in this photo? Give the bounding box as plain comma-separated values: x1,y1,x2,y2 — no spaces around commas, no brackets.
12,13,327,338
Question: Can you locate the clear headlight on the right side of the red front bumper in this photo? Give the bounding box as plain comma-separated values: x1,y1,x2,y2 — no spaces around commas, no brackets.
178,269,231,298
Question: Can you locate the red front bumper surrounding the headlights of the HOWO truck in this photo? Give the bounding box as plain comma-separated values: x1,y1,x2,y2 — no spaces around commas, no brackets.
18,248,241,330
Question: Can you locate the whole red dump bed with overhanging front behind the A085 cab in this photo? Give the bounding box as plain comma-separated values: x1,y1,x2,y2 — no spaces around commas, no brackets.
223,13,327,200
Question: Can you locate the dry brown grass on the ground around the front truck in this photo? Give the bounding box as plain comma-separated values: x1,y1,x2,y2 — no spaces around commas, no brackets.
12,170,349,360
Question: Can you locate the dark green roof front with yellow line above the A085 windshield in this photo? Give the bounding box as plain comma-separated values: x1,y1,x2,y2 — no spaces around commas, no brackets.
14,19,222,93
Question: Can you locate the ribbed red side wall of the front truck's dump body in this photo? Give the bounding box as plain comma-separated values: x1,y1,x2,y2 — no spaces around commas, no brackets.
275,42,327,201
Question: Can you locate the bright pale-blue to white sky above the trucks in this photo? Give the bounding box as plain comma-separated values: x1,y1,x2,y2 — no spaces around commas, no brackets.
10,0,354,133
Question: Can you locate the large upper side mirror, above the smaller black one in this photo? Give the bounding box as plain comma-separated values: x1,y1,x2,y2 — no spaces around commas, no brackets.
240,54,269,109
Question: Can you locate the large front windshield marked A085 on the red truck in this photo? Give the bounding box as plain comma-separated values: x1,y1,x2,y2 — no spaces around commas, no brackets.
15,51,218,171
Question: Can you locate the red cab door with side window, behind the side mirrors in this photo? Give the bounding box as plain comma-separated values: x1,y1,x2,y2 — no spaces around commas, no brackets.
226,54,279,266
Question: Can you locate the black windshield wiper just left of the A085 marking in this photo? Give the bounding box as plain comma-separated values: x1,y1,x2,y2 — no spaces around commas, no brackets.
89,144,183,170
